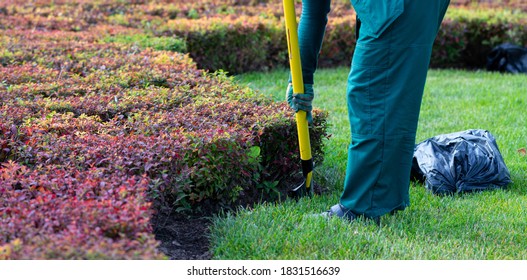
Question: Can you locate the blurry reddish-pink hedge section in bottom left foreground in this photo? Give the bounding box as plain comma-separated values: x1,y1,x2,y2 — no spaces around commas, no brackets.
0,162,164,260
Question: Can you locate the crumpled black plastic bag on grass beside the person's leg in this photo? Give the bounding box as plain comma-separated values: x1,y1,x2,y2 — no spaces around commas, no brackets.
412,129,511,194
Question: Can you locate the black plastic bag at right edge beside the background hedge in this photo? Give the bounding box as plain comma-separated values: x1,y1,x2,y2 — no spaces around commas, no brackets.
487,43,527,73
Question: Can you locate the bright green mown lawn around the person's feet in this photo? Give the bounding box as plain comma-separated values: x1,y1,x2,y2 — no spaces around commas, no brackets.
210,68,527,260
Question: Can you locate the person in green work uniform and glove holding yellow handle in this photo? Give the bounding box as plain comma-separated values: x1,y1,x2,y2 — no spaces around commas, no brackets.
286,0,450,221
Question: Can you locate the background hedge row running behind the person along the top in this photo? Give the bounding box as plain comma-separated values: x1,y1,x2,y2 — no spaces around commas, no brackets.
4,0,527,74
